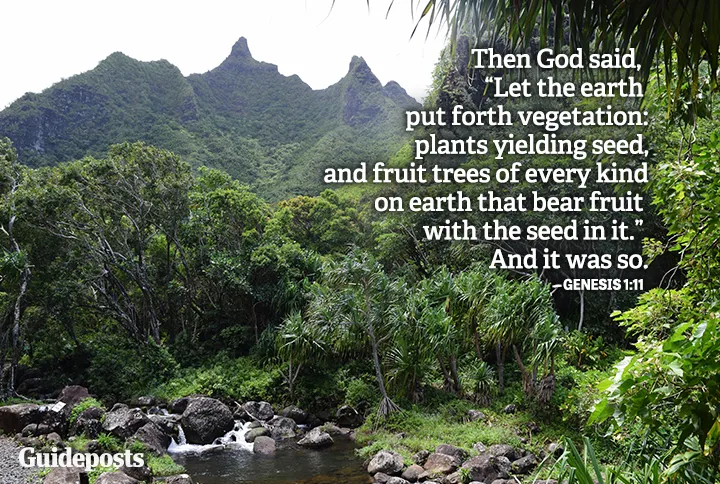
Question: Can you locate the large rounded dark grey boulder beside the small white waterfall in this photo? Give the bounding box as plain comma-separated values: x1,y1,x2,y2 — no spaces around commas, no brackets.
181,397,235,444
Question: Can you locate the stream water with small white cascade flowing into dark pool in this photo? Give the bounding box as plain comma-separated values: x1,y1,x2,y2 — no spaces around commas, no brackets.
168,422,372,484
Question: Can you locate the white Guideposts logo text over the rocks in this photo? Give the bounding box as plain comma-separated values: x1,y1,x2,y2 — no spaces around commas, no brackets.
18,447,145,472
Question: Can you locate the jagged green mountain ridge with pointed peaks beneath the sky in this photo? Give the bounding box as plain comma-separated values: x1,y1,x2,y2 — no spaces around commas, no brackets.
0,38,418,199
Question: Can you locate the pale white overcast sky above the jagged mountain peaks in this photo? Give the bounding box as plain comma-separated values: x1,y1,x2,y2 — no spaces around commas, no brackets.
0,0,445,109
